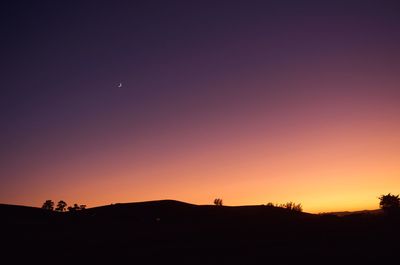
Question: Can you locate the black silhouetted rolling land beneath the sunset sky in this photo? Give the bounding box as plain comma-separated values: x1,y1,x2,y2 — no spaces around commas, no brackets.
0,201,400,264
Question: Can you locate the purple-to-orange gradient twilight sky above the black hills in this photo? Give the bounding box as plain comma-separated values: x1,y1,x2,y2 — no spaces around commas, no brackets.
0,0,400,210
